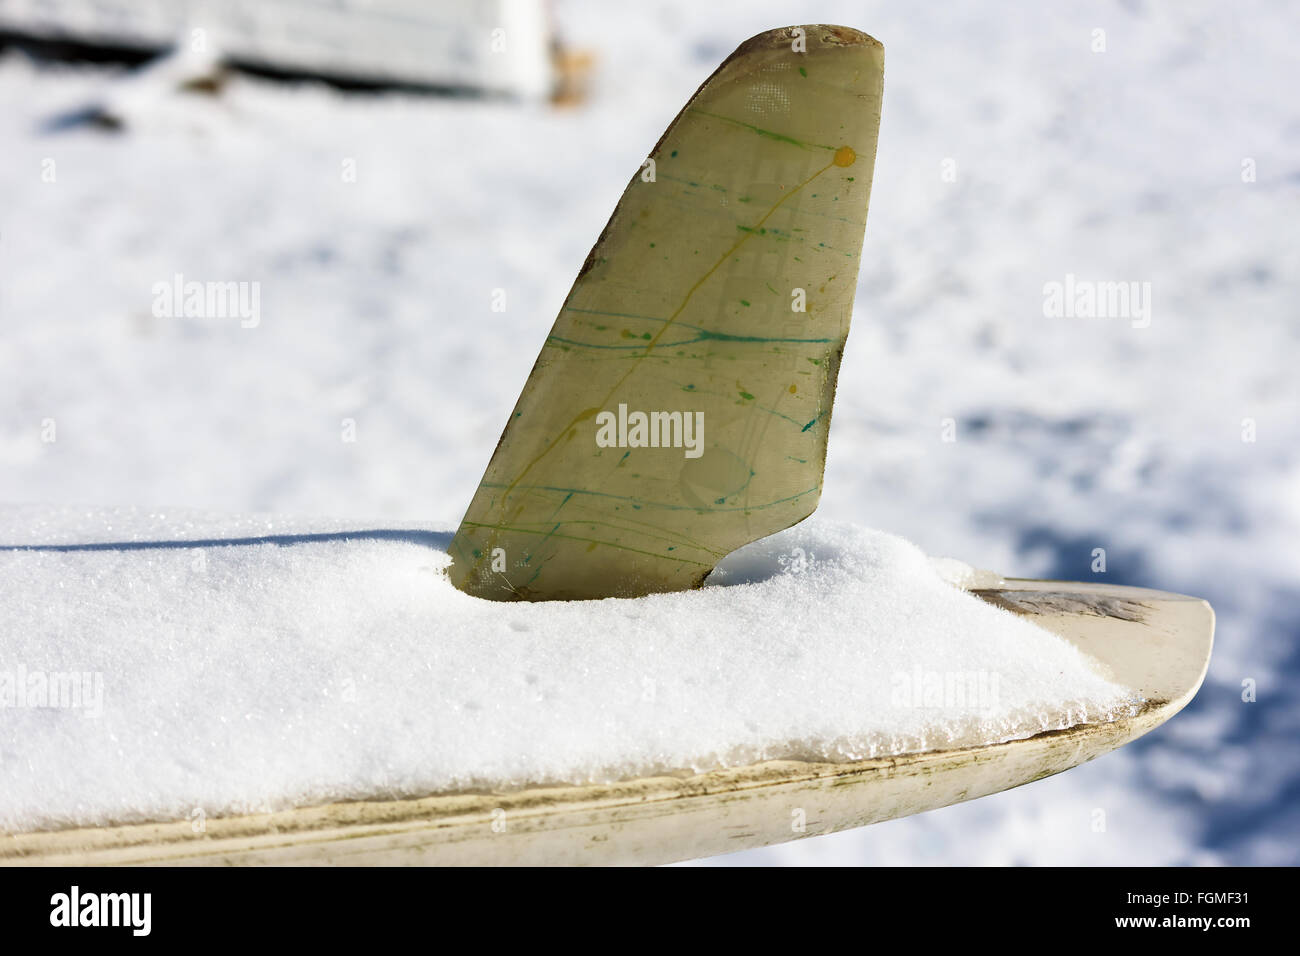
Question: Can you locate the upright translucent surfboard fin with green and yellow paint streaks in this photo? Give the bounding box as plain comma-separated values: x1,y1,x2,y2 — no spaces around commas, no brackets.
450,26,884,601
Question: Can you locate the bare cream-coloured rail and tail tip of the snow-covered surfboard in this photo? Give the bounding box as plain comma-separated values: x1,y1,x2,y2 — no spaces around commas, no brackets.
0,579,1214,866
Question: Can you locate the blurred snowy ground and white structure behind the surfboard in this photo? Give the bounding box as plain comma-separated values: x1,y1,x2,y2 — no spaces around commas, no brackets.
0,0,1300,864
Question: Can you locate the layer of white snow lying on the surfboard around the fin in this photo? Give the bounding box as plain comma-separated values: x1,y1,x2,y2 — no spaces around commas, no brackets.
0,507,1135,830
